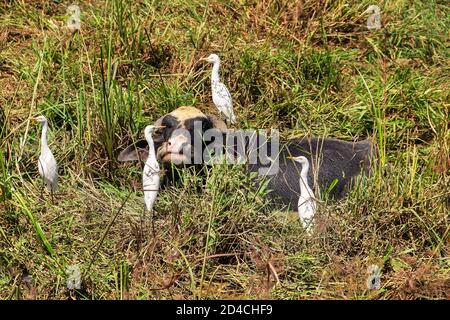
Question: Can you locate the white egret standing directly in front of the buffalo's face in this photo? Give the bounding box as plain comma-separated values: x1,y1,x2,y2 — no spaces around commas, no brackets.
142,126,160,212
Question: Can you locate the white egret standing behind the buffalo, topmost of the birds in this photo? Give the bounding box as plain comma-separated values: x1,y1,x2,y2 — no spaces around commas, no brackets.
201,53,236,124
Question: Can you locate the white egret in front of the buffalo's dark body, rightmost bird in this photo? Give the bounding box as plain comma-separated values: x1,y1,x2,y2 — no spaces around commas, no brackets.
289,156,316,230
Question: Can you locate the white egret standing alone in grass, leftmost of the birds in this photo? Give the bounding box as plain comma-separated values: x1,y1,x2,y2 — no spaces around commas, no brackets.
34,116,58,202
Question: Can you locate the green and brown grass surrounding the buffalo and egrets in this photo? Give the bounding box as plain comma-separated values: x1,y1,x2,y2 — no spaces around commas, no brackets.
0,0,450,299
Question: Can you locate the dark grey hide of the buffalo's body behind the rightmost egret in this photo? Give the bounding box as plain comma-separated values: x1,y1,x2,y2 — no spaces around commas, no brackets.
248,137,376,208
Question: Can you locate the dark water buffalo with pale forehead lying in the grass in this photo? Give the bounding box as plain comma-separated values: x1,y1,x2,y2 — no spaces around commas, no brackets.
118,107,376,208
